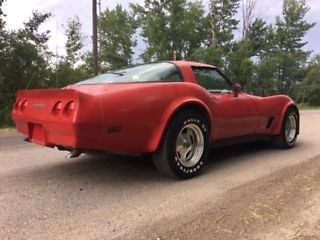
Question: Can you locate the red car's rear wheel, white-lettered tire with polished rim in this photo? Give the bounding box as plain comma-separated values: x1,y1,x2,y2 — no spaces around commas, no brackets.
152,111,210,179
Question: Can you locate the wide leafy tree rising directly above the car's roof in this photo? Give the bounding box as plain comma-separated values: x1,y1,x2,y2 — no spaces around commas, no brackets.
131,0,205,62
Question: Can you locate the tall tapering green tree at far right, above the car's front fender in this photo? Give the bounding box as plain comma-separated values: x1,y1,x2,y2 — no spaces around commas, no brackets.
258,0,314,94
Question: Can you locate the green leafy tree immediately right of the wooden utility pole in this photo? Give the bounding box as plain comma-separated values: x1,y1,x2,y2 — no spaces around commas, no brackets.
98,5,137,69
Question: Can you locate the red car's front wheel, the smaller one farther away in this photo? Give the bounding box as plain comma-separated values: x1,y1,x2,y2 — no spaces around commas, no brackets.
272,108,299,149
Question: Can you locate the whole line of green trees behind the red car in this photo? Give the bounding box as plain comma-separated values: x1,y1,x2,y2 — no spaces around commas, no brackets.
0,0,320,126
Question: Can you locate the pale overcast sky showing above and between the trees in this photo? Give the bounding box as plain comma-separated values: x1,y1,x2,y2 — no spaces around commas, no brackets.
3,0,320,60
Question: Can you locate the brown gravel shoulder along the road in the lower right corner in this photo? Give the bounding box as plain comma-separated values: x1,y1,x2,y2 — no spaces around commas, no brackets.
125,157,320,240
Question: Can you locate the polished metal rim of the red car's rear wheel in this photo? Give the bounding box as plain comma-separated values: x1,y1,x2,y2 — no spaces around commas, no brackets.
176,124,204,167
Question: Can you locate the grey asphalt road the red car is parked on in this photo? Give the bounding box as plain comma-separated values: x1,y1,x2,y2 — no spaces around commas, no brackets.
0,111,320,240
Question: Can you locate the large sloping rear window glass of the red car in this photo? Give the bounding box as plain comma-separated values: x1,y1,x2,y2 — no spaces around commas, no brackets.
77,63,183,84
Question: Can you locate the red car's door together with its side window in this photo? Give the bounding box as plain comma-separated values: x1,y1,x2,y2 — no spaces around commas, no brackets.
193,67,259,140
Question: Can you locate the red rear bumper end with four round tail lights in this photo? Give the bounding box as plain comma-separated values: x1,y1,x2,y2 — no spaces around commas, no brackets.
12,89,103,150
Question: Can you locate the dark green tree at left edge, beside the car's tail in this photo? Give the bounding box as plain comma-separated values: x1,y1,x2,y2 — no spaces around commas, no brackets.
0,12,52,124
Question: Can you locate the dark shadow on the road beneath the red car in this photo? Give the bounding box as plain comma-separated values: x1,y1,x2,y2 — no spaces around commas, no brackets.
14,142,299,186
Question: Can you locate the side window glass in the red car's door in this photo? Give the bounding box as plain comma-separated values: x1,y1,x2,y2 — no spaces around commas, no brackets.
193,67,232,92
